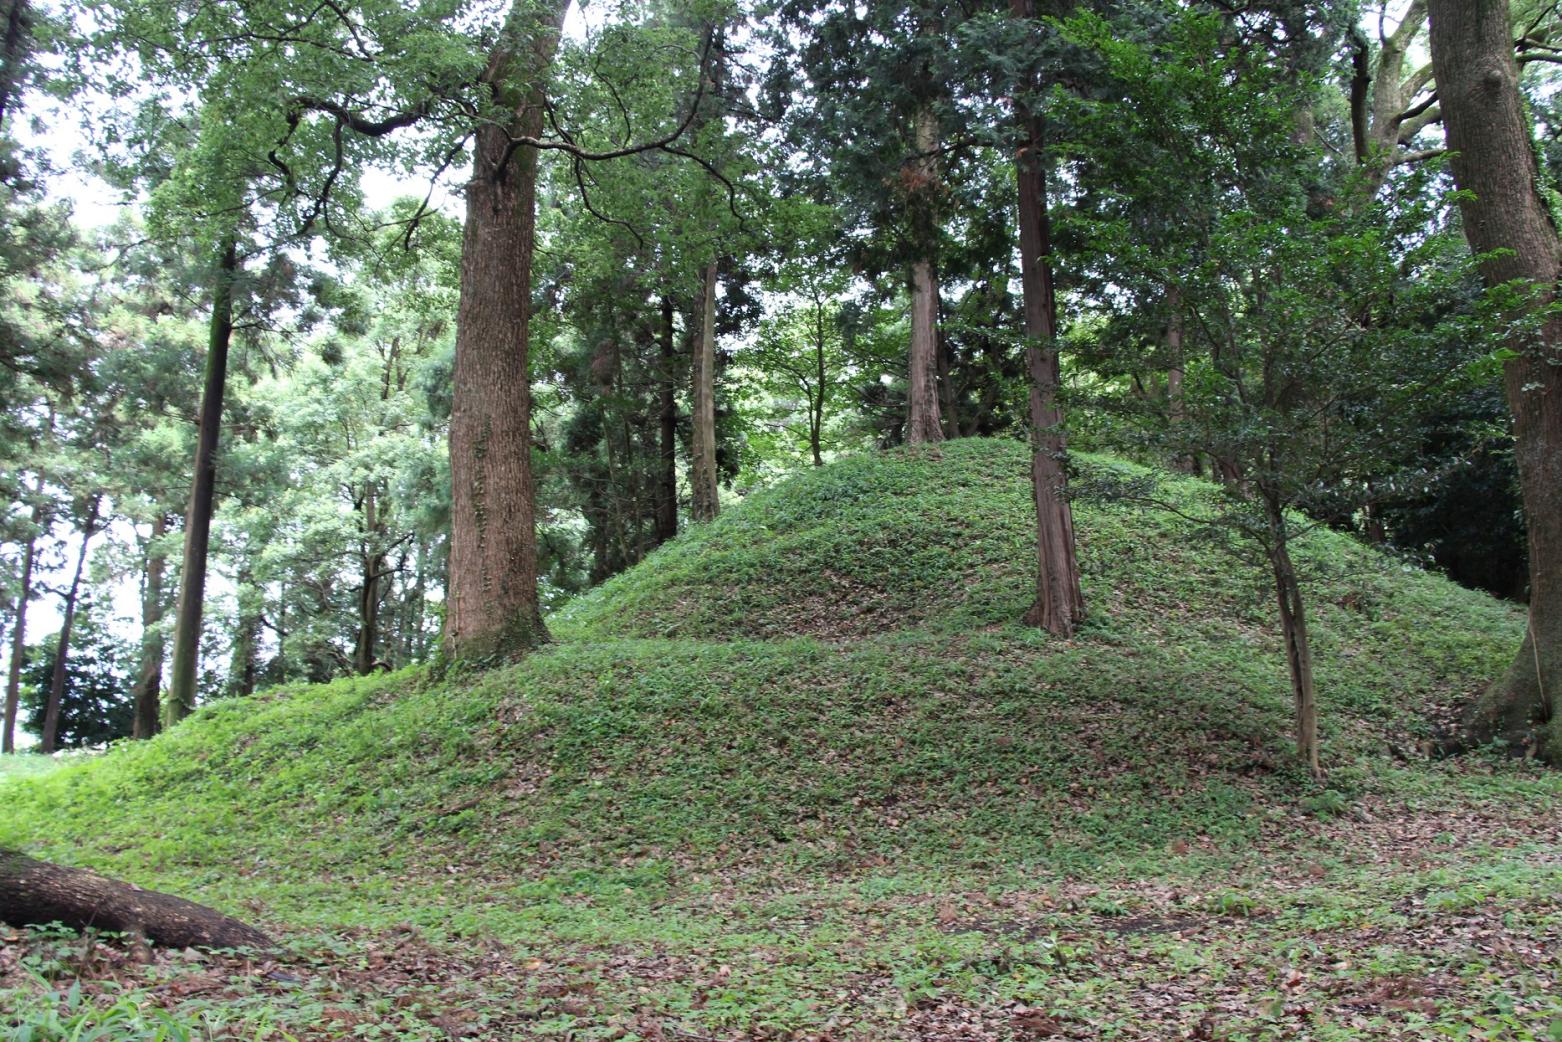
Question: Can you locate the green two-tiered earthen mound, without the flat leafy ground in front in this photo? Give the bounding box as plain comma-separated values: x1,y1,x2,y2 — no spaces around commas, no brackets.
0,442,1520,917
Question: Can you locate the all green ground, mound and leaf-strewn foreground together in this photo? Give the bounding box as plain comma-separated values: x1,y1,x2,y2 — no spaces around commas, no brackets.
0,442,1562,1042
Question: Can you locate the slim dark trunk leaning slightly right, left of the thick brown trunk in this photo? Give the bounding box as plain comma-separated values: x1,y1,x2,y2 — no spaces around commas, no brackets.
162,237,239,725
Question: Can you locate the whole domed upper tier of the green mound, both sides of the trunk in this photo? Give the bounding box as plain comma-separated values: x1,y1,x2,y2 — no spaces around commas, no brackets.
550,439,1524,642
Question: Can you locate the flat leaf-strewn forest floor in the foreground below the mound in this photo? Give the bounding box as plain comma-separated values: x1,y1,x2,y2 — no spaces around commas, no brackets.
0,765,1562,1042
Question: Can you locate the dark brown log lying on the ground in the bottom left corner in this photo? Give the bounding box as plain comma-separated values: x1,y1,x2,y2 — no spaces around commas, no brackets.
0,850,276,948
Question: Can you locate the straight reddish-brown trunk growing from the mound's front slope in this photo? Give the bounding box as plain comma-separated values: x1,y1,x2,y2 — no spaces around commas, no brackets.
1009,0,1084,637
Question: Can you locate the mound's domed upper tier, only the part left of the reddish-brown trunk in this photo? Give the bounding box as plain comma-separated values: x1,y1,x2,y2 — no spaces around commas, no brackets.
550,439,1034,639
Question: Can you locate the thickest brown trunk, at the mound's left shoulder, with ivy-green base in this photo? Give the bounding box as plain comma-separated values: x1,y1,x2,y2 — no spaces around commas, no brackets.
445,0,569,661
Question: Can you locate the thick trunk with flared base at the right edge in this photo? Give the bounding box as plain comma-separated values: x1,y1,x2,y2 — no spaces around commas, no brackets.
1428,0,1562,764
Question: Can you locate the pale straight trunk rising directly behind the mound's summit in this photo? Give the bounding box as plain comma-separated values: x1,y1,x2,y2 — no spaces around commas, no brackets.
906,105,943,445
